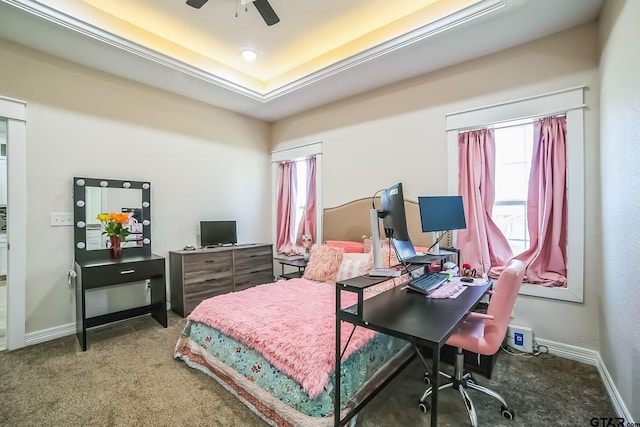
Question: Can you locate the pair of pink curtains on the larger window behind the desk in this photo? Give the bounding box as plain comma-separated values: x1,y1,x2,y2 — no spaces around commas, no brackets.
458,117,567,286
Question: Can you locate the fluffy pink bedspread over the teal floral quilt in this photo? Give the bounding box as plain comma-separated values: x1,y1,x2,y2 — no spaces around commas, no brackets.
189,279,375,398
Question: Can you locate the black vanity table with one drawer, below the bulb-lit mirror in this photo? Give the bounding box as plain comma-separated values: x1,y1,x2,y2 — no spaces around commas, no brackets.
75,254,167,351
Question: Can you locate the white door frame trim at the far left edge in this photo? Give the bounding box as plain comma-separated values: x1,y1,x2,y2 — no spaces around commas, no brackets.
0,97,27,350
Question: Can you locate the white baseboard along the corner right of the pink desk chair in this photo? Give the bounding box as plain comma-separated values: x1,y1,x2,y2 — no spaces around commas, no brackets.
536,338,634,423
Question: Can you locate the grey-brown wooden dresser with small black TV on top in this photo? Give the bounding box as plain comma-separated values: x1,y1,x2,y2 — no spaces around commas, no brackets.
169,243,274,317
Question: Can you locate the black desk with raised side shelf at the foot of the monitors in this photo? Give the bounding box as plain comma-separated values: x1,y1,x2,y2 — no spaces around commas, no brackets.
334,277,491,427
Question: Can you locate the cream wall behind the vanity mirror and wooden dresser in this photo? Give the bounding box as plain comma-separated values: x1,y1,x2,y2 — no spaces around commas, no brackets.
0,40,270,333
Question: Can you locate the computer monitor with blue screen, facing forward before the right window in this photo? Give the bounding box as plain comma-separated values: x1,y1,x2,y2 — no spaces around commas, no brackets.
418,196,467,254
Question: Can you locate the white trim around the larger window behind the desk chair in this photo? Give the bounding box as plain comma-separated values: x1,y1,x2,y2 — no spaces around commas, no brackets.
447,86,586,303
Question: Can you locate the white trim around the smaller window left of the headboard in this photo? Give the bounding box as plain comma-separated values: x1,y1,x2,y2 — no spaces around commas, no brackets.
271,142,322,251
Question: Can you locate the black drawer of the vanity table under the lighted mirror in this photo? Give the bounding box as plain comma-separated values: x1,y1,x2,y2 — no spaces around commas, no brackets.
82,259,164,289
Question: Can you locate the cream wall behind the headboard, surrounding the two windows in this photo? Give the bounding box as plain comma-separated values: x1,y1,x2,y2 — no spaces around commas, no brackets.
272,23,601,350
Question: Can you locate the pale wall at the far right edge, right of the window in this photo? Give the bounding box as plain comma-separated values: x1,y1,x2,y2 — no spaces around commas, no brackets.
594,0,640,422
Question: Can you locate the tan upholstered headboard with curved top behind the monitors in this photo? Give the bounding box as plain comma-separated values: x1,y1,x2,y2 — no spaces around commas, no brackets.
322,197,433,247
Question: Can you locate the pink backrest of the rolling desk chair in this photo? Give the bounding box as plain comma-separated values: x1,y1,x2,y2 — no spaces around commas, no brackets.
483,259,525,354
